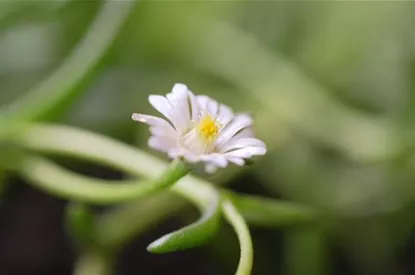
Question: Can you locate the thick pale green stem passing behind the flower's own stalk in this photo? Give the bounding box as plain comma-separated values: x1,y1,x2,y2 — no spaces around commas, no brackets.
14,124,217,208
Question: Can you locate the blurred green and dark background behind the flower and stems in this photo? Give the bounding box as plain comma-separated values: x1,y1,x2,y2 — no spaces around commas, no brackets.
0,1,415,275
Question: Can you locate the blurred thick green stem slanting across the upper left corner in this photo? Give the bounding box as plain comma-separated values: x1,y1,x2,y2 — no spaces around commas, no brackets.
0,1,135,120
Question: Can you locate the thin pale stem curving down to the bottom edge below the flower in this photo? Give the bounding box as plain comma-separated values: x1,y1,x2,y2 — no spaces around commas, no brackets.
222,199,253,275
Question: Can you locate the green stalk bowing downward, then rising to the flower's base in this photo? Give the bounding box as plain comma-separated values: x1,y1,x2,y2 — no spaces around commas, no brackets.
18,156,189,204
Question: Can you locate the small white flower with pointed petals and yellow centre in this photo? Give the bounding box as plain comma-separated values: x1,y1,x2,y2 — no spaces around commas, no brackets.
132,83,266,173
